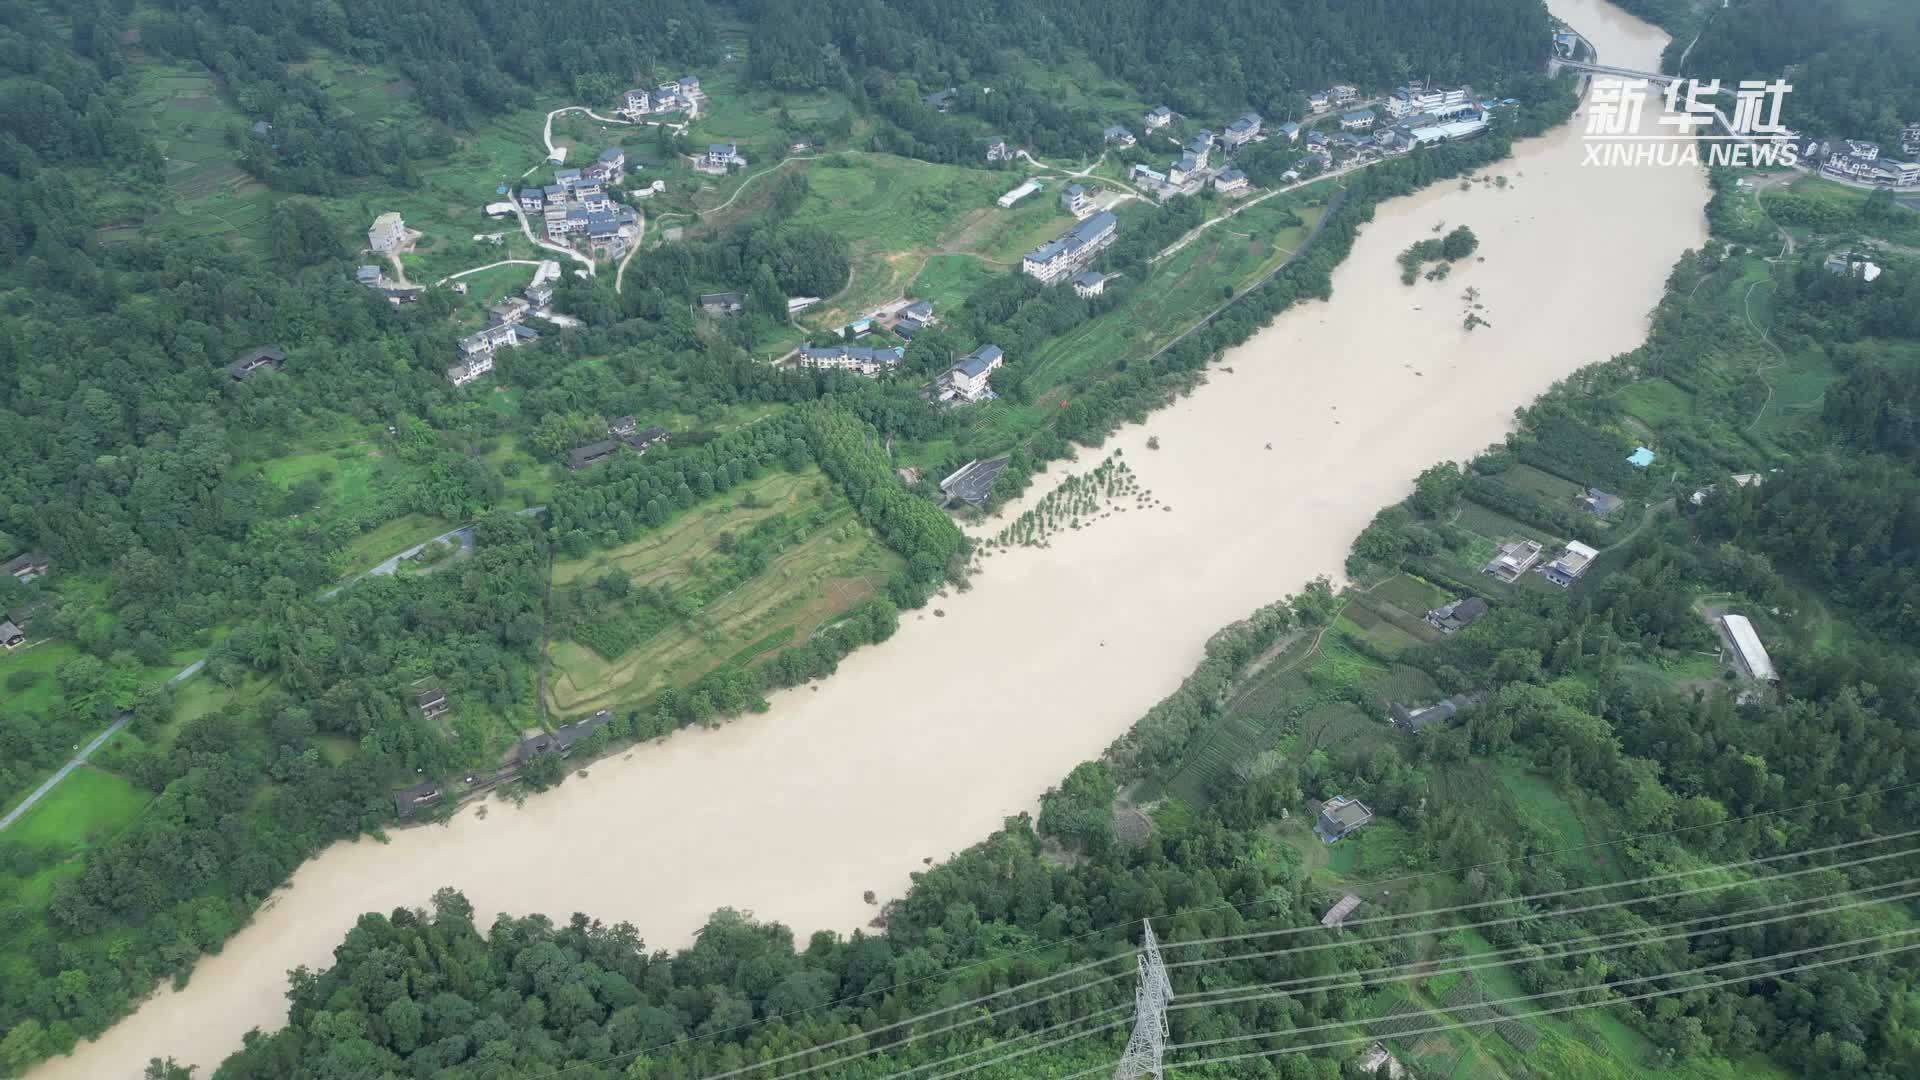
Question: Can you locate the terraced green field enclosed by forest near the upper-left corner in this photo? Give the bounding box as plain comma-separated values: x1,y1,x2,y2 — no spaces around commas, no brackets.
127,63,280,246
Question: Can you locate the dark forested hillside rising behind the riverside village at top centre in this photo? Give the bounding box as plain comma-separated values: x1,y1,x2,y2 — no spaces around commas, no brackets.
743,0,1548,160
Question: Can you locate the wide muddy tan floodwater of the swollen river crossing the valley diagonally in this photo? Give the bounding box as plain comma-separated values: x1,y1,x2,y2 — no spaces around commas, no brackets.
33,0,1707,1080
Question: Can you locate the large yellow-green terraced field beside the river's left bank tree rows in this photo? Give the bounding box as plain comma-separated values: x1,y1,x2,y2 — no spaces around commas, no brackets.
547,469,900,715
